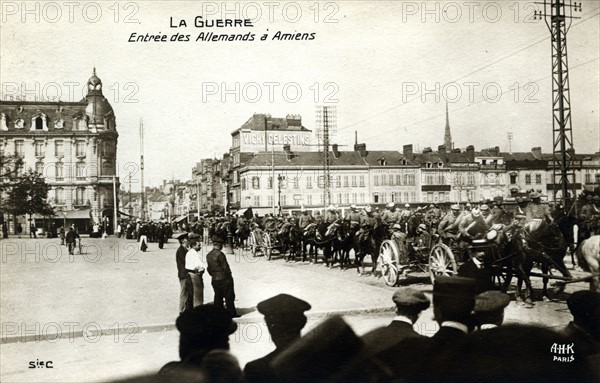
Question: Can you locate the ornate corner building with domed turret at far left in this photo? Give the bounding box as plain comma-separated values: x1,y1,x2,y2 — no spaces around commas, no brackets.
0,69,119,232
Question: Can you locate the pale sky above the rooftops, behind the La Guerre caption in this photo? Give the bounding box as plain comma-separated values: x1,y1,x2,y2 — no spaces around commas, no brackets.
0,0,600,188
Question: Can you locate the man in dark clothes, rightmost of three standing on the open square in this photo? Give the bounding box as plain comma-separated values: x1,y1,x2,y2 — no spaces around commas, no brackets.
206,237,241,318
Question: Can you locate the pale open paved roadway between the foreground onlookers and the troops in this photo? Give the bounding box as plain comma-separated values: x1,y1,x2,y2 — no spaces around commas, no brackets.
0,237,588,382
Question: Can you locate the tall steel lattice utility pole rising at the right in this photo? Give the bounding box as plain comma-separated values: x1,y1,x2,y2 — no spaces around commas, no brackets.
534,0,581,210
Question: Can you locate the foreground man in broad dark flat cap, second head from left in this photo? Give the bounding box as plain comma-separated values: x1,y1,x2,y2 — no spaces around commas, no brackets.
244,294,311,383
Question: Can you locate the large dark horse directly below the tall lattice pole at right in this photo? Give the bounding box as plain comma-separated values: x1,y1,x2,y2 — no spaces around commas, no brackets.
517,220,572,303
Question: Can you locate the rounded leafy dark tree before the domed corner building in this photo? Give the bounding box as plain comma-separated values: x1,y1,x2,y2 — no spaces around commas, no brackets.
4,170,54,220
